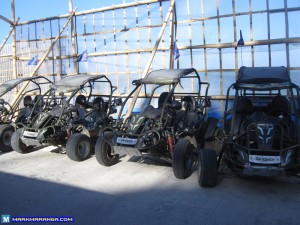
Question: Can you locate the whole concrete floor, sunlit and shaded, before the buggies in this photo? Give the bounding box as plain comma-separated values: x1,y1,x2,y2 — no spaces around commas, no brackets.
0,148,300,225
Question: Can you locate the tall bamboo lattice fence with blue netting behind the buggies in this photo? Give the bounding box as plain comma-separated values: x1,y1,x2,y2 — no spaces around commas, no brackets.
0,0,300,118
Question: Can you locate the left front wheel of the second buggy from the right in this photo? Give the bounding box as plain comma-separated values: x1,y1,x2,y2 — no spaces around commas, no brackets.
95,133,119,166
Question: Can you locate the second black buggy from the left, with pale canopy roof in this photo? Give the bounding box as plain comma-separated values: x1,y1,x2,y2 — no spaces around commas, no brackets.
12,74,116,161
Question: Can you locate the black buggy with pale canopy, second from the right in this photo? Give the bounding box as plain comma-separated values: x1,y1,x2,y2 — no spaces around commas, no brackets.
95,68,210,179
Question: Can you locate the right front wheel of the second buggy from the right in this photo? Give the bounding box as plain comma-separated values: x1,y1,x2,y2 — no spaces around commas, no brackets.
173,139,194,179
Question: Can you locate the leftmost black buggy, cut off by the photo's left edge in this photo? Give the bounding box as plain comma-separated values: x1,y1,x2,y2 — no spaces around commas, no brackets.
0,76,52,152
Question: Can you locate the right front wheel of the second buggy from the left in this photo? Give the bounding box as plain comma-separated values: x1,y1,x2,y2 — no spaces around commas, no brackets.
66,133,91,162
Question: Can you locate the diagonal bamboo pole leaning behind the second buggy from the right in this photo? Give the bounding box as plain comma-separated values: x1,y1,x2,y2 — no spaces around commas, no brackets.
125,0,175,119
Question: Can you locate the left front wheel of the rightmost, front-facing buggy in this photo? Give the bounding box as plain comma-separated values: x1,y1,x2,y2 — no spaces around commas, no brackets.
197,149,218,187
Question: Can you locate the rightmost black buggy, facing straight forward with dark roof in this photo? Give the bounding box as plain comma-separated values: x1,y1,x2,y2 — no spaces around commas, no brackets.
198,67,300,187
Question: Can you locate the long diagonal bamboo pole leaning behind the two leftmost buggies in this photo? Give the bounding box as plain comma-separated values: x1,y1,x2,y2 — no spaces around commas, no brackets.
11,7,77,108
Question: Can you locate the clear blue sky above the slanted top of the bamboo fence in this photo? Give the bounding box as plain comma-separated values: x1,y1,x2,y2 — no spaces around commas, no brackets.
0,0,127,43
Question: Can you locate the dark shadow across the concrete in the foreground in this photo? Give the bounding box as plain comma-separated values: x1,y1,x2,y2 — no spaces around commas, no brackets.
0,172,300,225
